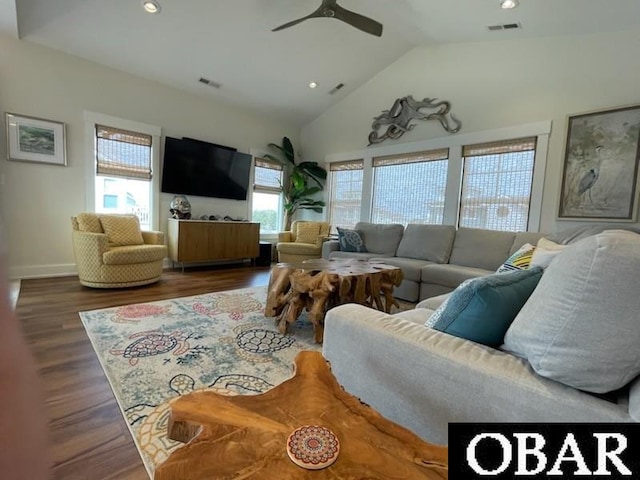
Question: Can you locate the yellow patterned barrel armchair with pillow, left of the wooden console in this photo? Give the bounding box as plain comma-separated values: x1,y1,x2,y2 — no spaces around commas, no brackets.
71,213,167,288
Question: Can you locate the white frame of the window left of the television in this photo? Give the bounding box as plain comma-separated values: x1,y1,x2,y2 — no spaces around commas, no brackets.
84,111,162,230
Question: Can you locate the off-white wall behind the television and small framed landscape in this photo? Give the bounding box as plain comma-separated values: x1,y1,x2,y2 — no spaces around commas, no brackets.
0,35,299,278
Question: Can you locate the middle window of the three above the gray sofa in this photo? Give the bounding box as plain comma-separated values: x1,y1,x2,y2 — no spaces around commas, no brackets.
371,148,449,225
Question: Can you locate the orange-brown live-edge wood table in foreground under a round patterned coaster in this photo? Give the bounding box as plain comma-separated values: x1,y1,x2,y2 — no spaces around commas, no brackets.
154,352,448,480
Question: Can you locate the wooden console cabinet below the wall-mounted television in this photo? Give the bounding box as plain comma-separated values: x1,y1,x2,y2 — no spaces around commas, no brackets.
167,218,260,265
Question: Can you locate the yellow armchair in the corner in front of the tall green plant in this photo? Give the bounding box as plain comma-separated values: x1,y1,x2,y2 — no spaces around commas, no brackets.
276,220,331,263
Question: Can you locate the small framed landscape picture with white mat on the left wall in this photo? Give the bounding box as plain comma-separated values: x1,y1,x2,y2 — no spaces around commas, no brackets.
5,113,67,165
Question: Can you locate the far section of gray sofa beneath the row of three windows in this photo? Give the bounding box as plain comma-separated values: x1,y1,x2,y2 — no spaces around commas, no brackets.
322,222,542,302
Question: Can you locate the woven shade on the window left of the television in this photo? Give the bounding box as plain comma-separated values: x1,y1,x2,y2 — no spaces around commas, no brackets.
96,125,152,180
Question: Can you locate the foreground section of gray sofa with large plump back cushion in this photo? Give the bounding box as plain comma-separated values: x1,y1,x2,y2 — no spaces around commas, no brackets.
323,225,640,444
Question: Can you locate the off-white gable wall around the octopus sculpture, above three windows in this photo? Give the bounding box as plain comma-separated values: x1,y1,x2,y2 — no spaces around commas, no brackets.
301,31,640,231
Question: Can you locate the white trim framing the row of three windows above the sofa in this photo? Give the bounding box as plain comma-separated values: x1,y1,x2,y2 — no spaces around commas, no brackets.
325,120,551,232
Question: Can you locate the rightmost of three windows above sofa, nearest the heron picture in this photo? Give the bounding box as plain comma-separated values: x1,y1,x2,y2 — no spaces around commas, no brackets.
458,137,536,231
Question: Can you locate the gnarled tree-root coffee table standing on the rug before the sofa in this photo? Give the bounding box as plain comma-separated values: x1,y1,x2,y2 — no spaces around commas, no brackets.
264,259,402,343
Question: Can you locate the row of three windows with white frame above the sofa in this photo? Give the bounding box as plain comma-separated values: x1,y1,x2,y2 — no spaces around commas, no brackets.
325,120,551,232
